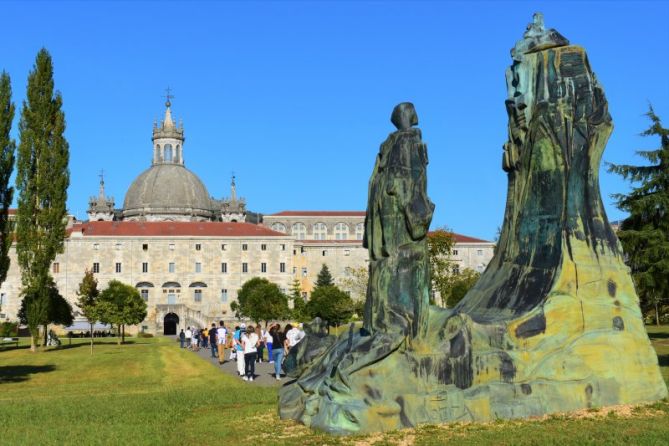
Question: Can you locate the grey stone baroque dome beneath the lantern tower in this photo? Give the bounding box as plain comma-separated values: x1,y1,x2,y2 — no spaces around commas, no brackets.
123,164,213,221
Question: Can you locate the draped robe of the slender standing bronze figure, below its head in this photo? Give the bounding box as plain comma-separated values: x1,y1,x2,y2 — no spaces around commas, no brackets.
363,128,434,336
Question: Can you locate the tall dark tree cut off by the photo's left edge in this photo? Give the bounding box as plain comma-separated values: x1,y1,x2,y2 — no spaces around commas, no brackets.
0,71,16,305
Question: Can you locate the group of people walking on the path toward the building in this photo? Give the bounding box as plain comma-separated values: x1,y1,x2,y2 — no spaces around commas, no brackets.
179,321,305,381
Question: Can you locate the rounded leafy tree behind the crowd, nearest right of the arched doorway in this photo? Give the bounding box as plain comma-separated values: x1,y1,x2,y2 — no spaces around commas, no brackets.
230,277,290,324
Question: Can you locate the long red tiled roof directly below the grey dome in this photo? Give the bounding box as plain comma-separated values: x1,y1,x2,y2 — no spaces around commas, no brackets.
71,221,286,237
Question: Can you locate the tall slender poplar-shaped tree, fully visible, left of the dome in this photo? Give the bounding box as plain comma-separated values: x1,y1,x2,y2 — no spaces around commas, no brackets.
16,48,70,351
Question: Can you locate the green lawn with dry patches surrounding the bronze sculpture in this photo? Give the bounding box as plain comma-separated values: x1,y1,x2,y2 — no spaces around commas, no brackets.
0,327,669,446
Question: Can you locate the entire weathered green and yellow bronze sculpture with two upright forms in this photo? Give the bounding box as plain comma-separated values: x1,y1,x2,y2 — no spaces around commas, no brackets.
279,15,667,434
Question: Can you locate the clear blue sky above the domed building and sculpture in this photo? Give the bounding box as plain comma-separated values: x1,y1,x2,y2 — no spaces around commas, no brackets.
0,1,669,239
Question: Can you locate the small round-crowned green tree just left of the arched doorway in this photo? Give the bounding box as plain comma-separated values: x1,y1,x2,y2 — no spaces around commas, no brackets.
96,280,146,344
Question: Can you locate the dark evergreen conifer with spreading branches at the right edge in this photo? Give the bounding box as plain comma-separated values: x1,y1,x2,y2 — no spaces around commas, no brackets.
608,107,669,325
